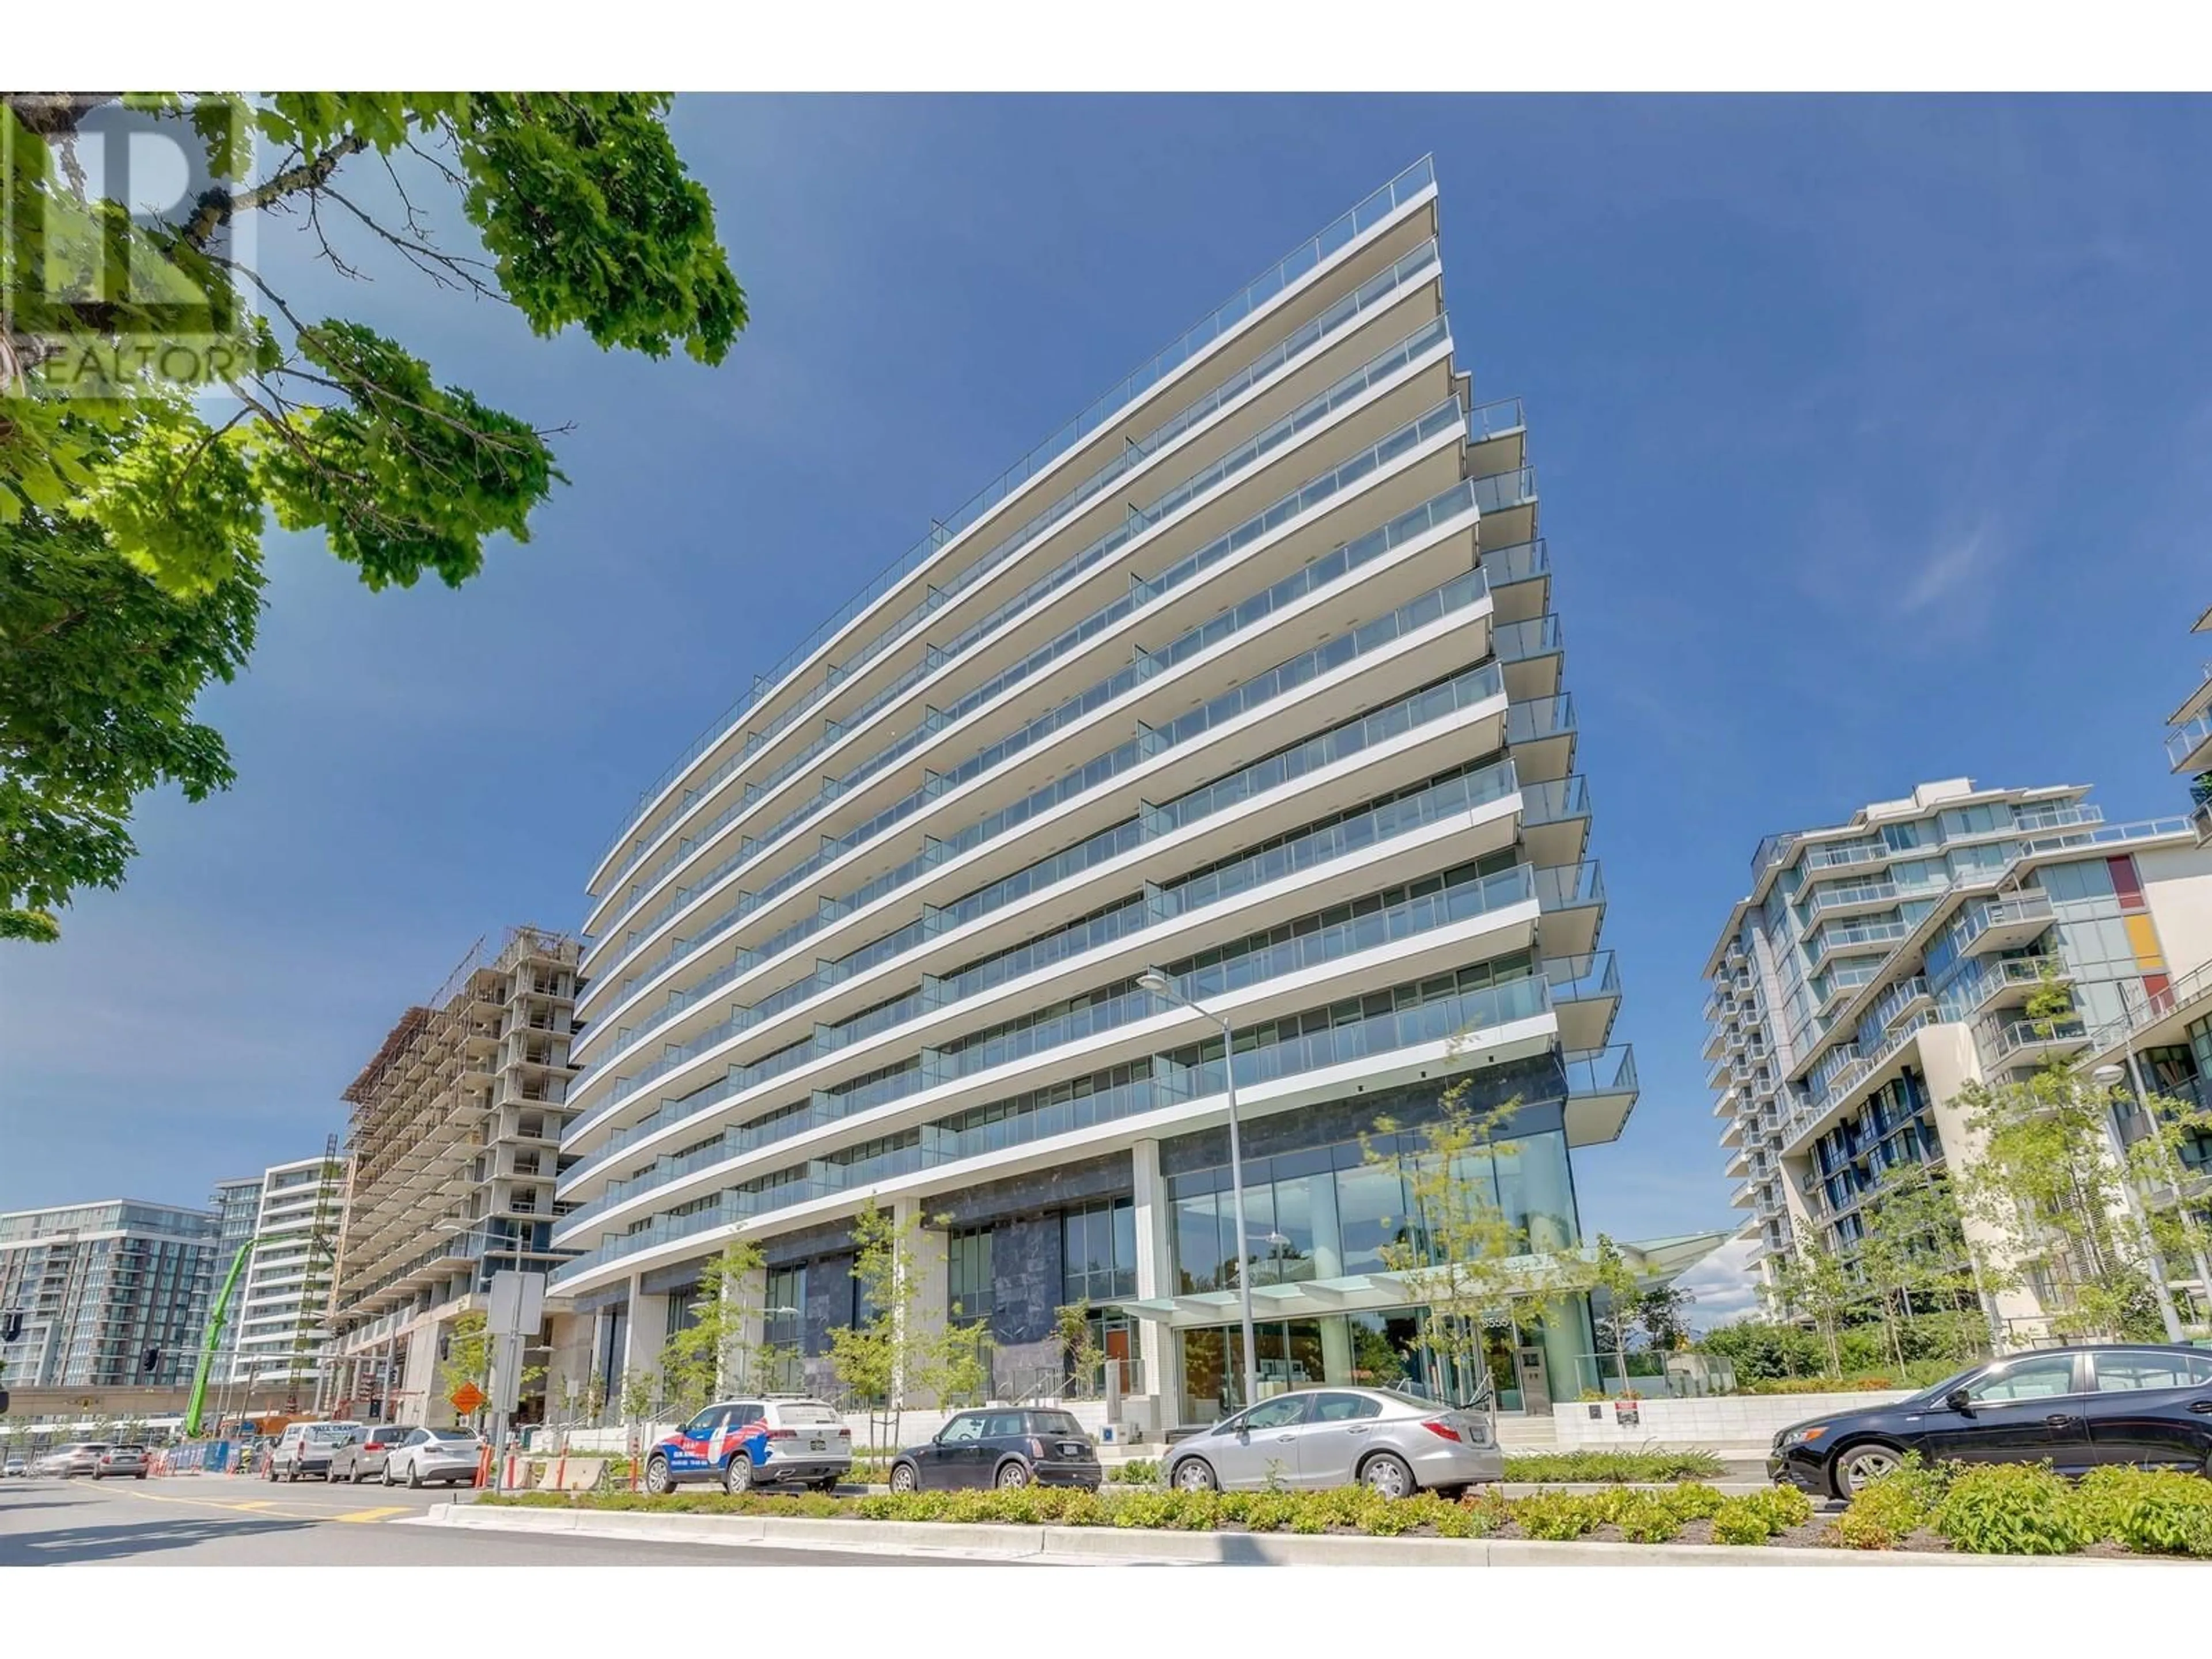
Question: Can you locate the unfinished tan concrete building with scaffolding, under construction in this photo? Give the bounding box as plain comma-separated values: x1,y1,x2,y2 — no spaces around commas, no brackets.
325,927,577,1425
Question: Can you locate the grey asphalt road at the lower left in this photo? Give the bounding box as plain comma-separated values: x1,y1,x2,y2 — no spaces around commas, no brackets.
0,1475,988,1566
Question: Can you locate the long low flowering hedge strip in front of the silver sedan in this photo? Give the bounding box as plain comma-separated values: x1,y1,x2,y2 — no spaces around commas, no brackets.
478,1484,1812,1544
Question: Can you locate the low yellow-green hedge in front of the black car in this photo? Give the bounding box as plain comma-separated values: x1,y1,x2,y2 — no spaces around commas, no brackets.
1827,1458,2212,1557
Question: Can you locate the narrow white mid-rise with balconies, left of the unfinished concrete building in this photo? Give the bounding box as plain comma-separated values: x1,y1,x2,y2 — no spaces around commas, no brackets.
213,1148,345,1391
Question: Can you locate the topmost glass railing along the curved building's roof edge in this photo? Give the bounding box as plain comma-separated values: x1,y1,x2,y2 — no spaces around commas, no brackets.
601,172,1435,885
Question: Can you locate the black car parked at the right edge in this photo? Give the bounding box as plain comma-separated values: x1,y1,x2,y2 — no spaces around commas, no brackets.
1767,1343,2212,1498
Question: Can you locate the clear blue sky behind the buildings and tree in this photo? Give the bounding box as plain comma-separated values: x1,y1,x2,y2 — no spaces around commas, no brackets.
0,97,2212,1327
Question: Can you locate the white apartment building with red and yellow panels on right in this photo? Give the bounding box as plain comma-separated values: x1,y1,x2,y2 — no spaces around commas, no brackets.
1706,779,2212,1338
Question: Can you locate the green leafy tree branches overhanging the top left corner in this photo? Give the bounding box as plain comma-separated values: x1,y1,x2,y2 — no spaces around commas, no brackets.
0,93,745,940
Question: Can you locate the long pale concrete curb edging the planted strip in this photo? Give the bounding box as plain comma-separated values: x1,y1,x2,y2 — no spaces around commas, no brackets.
414,1504,2157,1570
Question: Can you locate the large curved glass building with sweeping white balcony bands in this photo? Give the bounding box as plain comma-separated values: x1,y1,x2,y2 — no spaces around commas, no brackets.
553,164,1710,1427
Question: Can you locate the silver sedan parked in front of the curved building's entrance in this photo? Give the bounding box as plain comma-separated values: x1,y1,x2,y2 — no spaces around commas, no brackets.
1166,1387,1506,1498
